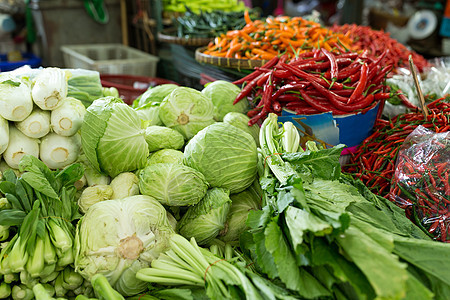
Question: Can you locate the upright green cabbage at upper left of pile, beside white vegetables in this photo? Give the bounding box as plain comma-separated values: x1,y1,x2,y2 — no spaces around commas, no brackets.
81,97,149,177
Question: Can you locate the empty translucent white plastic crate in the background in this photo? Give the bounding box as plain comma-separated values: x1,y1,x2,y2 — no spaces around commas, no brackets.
61,44,159,77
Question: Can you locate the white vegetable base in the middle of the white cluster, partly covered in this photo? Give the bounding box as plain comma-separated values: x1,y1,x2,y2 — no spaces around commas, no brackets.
16,108,50,139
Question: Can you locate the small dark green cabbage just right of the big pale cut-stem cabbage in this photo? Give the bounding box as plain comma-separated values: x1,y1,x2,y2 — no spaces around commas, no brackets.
177,188,231,245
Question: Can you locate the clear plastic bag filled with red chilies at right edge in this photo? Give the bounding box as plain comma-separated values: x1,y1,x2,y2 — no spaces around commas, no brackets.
389,126,450,243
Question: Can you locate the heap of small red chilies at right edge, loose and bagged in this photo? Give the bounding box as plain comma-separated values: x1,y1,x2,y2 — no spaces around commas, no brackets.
343,98,450,242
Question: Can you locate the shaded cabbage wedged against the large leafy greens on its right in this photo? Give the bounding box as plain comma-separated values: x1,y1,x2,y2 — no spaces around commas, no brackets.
218,180,262,244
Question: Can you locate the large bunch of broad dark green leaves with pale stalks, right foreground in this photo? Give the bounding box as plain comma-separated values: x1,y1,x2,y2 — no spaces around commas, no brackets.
241,114,450,299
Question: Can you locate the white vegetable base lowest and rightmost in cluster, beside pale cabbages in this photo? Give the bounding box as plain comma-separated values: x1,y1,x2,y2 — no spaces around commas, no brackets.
40,133,81,169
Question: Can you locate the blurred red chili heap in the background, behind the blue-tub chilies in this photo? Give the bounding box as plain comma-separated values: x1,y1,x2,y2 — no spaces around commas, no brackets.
330,24,430,72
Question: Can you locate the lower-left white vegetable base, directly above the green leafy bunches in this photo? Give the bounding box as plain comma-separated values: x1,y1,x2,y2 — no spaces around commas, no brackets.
3,126,39,169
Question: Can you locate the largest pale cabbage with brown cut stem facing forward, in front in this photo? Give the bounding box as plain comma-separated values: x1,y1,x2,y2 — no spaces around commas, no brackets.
75,195,174,296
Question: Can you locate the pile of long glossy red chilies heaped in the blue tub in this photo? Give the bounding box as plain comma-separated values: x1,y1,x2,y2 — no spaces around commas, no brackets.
234,48,392,125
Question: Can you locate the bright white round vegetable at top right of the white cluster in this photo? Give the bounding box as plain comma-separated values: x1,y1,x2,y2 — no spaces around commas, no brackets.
31,68,68,110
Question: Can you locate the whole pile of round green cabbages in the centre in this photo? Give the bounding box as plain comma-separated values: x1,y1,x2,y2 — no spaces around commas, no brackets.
59,81,262,296
